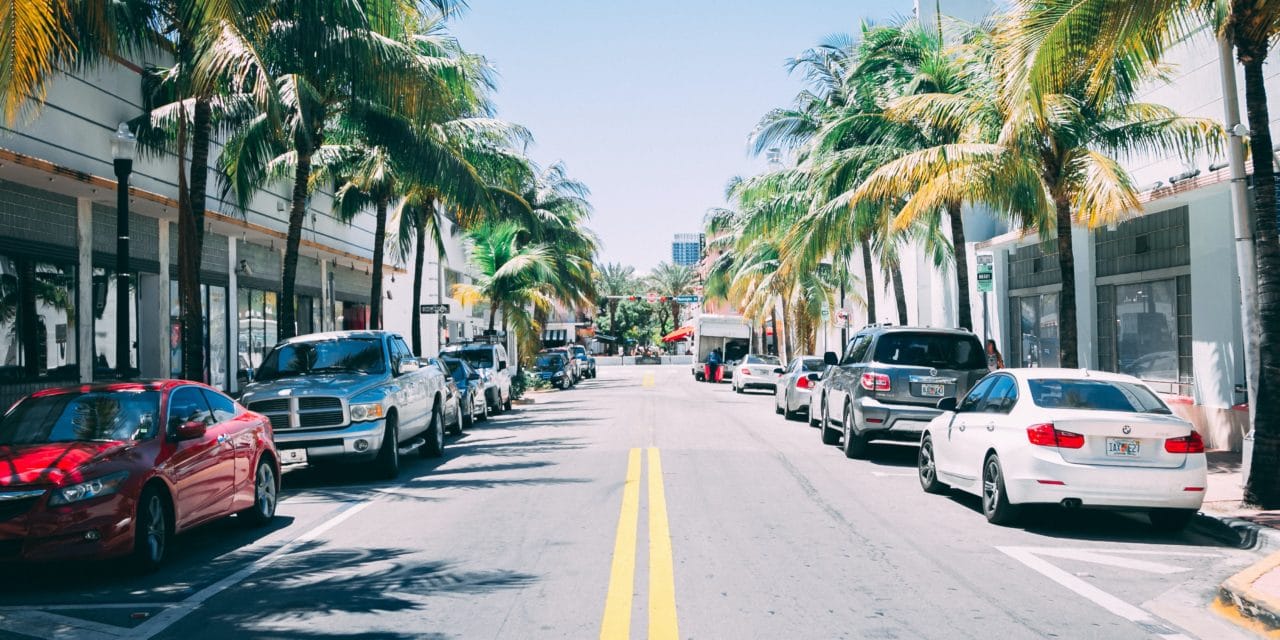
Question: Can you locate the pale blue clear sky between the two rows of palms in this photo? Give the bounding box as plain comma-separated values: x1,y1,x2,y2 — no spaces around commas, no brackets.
451,0,914,271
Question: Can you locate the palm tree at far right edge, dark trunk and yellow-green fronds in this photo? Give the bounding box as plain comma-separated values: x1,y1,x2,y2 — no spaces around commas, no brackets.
1010,0,1280,508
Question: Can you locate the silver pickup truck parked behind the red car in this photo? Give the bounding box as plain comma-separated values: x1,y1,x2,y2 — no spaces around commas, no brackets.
241,332,445,477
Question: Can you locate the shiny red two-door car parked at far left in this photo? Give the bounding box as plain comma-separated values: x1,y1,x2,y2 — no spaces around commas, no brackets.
0,380,280,570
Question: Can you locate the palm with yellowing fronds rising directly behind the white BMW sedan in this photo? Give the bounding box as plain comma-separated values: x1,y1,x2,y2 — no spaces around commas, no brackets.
852,23,1224,367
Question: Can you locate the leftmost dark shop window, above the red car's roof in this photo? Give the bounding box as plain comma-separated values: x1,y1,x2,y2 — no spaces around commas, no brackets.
0,256,78,383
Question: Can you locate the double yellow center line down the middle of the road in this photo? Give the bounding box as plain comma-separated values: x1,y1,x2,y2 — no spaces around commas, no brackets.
600,447,680,640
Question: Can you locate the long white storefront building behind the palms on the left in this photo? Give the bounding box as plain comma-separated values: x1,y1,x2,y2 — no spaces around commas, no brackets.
0,57,476,406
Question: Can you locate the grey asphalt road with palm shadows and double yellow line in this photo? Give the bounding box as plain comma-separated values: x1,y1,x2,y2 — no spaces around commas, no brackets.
0,366,1256,640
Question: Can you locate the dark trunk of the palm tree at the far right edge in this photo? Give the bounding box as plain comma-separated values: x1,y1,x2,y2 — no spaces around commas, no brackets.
1239,51,1280,509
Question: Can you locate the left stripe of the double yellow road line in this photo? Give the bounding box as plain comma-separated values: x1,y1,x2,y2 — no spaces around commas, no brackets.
600,449,640,640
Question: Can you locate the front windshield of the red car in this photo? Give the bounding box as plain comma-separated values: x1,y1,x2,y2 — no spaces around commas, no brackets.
0,389,160,445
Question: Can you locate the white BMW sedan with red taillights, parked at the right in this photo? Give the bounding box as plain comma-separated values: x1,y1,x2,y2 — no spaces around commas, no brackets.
919,369,1207,530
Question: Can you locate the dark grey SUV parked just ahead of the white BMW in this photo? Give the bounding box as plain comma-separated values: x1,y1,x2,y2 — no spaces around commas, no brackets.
822,325,988,458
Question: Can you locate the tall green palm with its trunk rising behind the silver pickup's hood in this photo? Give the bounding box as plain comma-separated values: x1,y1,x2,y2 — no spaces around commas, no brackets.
209,0,460,339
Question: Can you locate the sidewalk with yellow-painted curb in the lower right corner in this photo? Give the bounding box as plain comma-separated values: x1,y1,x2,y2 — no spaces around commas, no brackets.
1202,452,1280,635
